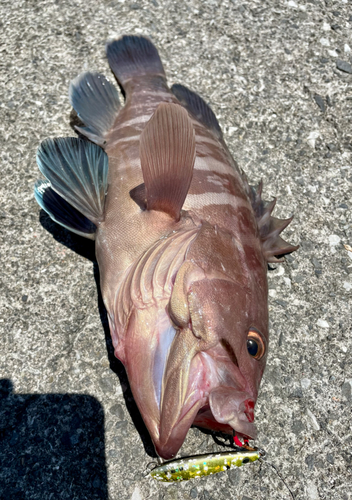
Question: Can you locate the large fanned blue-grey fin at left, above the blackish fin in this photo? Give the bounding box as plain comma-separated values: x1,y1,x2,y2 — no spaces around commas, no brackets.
37,137,108,225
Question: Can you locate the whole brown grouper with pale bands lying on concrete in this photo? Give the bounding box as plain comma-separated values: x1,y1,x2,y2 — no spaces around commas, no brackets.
35,36,298,459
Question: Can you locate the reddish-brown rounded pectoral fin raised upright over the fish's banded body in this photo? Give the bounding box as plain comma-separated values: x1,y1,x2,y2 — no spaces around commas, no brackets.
139,103,196,220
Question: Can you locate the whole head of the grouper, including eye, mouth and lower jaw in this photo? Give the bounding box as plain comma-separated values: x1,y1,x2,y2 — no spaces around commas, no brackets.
112,224,268,459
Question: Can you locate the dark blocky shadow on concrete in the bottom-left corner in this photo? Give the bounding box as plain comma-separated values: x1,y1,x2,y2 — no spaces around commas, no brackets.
0,379,108,500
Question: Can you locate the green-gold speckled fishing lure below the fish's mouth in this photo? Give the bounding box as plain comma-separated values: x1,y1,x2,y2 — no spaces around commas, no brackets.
150,448,265,483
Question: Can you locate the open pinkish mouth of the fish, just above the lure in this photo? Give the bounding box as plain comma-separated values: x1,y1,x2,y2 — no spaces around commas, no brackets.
153,346,257,459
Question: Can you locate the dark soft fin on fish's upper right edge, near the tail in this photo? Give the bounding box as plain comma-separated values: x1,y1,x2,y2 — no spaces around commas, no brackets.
171,83,222,139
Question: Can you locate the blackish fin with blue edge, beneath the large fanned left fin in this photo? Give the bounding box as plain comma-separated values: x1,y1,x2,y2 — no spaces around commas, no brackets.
34,180,97,240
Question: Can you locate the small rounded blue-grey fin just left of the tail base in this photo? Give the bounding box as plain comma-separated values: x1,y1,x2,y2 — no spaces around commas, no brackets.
69,73,120,146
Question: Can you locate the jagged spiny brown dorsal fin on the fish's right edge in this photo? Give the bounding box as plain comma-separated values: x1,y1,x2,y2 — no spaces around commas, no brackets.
242,174,299,262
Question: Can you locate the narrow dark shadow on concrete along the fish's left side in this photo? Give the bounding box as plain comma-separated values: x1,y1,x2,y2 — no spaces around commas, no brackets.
39,210,157,458
